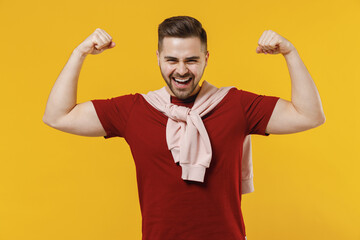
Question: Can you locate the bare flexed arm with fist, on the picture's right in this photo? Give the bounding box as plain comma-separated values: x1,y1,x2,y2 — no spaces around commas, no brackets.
256,30,325,134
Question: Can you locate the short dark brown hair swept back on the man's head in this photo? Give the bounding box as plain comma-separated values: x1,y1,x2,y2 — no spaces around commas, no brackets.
158,16,207,53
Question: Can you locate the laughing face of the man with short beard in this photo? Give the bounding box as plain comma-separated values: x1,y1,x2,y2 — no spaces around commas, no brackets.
156,37,209,99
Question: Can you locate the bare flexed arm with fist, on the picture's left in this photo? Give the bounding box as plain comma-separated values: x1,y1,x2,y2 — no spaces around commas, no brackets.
43,29,115,137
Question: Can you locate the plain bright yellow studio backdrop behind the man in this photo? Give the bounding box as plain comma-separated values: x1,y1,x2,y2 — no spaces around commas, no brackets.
0,0,360,240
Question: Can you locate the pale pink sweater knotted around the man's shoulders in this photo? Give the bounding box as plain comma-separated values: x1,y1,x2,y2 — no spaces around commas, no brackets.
142,81,254,194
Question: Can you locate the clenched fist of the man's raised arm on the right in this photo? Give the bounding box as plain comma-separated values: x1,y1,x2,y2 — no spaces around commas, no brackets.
256,30,295,55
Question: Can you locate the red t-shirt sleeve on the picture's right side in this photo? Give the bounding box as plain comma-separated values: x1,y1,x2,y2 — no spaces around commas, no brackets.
239,90,280,136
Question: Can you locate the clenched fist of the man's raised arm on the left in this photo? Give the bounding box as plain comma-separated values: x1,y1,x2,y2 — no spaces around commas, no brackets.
76,28,115,56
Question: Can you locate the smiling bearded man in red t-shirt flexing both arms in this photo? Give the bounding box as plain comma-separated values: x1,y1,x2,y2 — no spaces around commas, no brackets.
43,16,325,240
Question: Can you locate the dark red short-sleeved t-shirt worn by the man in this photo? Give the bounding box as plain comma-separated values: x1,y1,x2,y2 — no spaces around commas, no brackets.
92,88,279,240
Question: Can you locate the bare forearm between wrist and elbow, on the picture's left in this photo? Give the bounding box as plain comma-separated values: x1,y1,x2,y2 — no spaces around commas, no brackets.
43,49,85,123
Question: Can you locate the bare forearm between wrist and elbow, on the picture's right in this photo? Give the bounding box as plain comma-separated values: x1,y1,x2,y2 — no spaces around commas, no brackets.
284,49,325,122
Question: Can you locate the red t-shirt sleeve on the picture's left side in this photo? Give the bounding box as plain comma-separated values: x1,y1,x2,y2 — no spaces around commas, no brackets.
91,94,135,139
